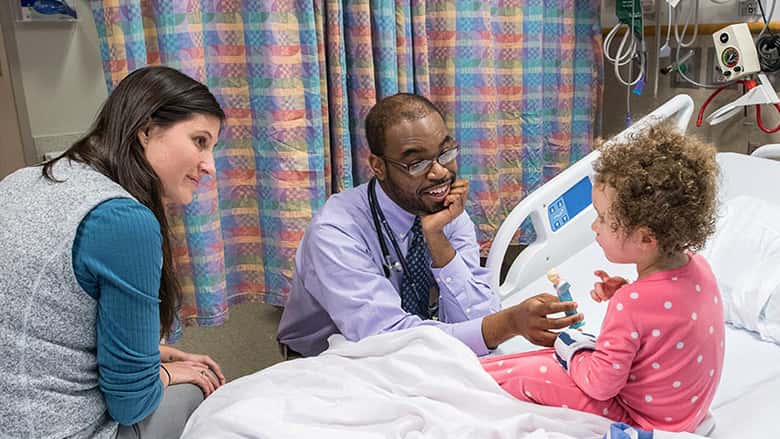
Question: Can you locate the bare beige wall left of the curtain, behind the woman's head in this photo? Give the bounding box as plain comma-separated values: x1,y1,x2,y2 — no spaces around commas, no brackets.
14,0,107,156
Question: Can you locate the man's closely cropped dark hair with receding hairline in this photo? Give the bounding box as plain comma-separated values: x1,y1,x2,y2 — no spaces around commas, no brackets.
365,93,444,157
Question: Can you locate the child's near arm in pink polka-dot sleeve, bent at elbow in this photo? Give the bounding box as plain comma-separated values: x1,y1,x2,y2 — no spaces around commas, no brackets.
556,288,640,401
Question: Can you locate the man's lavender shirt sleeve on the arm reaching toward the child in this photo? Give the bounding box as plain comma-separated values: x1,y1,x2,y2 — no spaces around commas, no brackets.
303,224,488,355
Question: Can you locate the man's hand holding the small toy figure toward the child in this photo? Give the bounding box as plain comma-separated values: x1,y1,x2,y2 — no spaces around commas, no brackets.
482,293,584,349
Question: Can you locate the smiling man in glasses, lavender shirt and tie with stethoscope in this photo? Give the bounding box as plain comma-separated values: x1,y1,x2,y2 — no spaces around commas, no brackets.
278,93,582,357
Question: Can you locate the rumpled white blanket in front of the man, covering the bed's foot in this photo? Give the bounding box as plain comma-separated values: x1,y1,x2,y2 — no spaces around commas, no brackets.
182,327,694,439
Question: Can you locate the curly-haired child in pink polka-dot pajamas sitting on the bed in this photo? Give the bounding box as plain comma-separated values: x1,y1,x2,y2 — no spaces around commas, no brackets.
482,125,724,431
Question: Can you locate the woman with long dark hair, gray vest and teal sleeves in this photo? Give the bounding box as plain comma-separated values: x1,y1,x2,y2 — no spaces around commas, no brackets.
0,67,225,438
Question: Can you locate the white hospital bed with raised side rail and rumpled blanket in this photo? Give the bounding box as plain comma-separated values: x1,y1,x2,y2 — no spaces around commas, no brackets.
182,96,780,439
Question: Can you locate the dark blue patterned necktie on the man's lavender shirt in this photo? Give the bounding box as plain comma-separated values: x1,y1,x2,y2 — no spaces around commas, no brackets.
401,216,435,319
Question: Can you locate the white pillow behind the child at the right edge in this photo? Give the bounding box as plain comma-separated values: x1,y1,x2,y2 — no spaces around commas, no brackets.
701,196,780,343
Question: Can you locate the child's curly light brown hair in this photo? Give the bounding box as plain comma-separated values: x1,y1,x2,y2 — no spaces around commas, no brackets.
593,123,718,255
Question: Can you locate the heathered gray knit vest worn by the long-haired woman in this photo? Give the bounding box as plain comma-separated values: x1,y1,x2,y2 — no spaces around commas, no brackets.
0,159,132,438
